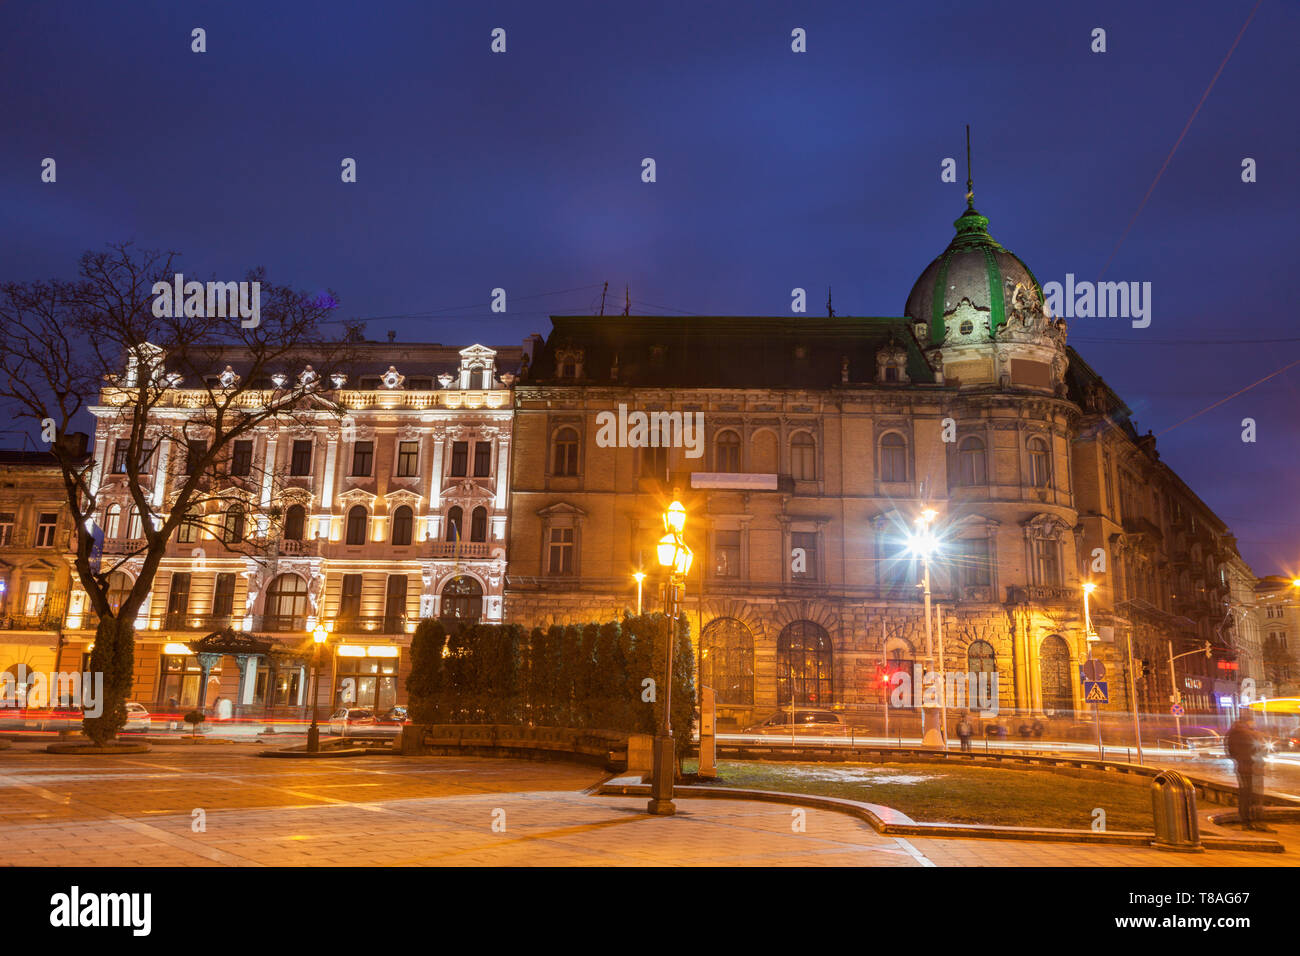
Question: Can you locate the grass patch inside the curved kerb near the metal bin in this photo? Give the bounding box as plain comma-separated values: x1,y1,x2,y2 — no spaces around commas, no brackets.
683,761,1153,832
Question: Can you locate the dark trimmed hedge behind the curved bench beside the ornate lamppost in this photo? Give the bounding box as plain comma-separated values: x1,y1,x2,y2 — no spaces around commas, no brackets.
407,614,696,758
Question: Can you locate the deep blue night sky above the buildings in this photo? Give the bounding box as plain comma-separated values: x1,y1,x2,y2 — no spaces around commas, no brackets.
0,0,1300,575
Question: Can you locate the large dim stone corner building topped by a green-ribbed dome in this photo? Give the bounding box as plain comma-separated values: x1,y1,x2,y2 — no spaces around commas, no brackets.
506,195,1239,726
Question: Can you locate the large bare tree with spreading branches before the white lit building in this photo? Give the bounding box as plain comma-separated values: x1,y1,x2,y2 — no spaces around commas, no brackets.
0,242,347,744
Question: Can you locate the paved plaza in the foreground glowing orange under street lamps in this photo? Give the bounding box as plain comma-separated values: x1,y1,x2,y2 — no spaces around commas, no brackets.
0,745,1300,866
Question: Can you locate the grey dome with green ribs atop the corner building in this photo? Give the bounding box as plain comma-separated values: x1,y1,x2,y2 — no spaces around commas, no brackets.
904,195,1043,345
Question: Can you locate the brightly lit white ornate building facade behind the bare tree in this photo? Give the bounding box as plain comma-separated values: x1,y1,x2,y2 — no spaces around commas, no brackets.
58,342,521,715
